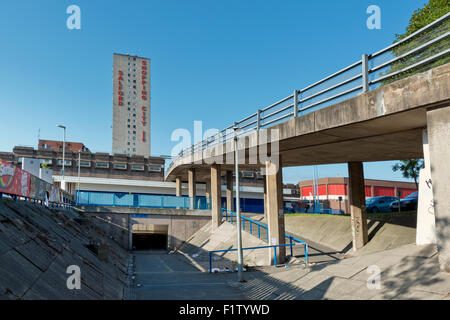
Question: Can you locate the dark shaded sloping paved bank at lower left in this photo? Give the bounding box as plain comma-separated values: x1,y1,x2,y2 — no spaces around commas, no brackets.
0,199,129,300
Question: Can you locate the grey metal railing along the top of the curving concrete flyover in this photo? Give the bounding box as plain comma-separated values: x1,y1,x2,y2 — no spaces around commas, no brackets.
168,13,450,171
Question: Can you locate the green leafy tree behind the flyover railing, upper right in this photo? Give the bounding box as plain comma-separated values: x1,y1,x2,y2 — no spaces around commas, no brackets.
381,0,450,84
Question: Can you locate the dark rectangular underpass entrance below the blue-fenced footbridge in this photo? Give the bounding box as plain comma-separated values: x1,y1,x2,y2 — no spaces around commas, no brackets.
132,224,169,250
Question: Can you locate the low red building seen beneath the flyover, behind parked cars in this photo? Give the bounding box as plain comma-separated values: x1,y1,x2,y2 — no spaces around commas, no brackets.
299,178,417,213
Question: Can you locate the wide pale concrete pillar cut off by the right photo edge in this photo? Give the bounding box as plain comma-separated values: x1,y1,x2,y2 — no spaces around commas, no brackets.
427,105,450,272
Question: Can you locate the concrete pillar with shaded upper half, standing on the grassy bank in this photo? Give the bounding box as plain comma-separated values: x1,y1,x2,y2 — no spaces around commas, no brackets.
348,162,368,251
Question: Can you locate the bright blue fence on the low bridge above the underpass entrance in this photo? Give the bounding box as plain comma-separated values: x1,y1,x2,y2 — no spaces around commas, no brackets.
76,191,211,210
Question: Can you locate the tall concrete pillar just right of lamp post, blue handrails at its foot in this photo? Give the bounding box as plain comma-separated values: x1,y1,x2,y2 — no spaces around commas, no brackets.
266,161,286,264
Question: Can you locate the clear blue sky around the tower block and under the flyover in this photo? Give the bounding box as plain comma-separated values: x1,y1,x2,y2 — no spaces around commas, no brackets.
0,0,425,183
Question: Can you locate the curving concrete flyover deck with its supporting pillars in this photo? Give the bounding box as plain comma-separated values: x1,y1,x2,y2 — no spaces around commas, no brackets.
165,63,450,272
